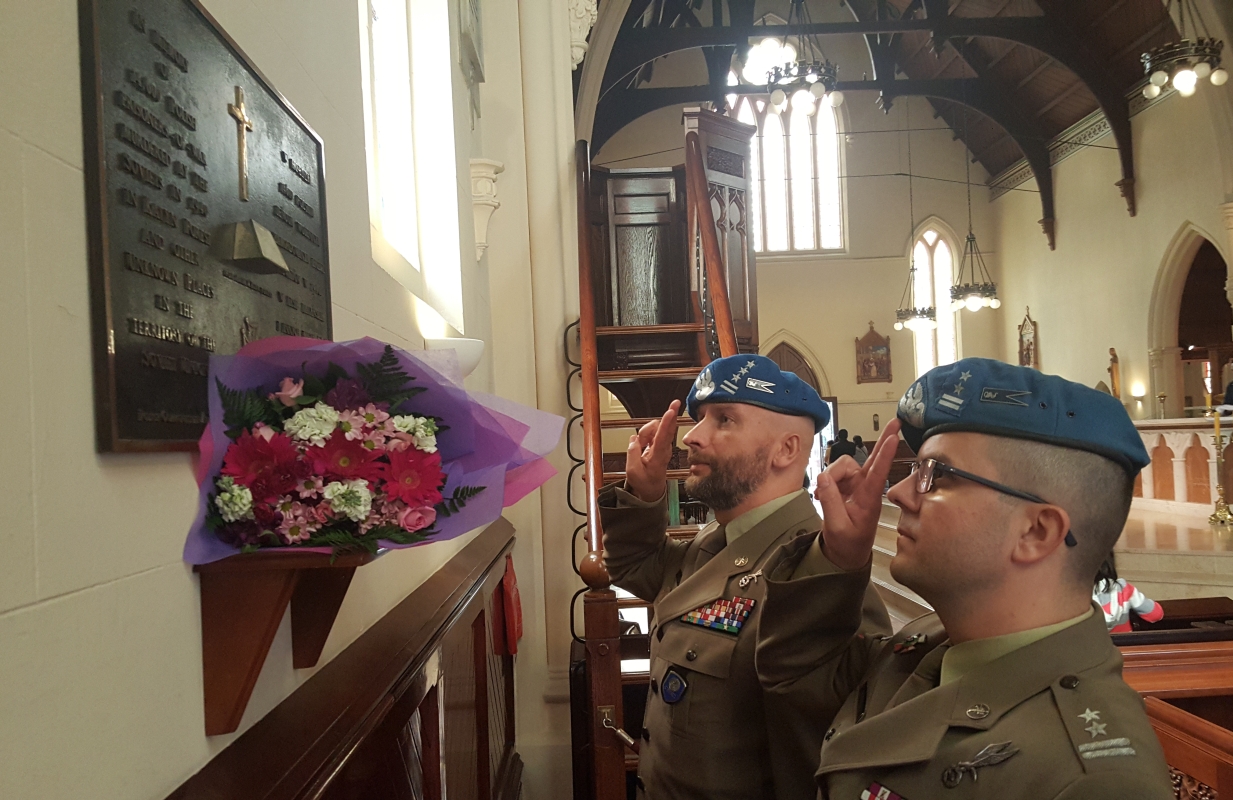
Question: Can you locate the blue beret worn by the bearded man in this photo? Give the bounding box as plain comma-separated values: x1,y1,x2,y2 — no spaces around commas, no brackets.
686,354,831,433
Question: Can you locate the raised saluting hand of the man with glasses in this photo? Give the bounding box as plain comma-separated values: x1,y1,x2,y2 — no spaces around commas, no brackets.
814,419,900,571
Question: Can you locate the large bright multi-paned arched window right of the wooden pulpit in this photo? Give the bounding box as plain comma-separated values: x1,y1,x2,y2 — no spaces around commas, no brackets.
727,86,843,253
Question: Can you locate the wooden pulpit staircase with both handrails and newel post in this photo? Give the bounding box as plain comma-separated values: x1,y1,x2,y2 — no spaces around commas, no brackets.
571,131,739,800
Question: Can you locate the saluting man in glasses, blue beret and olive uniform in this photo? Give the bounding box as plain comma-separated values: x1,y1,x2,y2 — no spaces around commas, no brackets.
757,359,1173,800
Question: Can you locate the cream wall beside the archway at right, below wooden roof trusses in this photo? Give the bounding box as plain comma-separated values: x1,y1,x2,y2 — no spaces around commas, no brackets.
994,88,1233,415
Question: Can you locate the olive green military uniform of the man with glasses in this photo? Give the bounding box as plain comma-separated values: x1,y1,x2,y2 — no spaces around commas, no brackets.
757,536,1173,800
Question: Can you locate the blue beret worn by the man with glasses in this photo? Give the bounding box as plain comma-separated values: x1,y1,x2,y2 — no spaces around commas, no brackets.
899,359,1150,476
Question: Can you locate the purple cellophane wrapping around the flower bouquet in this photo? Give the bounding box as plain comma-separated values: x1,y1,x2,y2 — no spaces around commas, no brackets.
184,337,565,563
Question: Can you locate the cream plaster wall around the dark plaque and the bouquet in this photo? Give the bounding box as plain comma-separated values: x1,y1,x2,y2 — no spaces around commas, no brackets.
0,0,542,800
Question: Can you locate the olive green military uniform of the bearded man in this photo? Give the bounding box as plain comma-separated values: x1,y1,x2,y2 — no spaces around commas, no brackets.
600,489,890,800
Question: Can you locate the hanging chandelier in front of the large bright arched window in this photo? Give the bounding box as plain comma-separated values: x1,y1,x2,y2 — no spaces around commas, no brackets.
741,0,843,115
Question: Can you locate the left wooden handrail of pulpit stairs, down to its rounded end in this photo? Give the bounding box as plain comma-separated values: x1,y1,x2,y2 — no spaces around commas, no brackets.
575,141,609,590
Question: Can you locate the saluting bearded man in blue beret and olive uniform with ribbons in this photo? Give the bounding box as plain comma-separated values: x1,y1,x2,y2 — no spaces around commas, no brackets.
600,355,890,800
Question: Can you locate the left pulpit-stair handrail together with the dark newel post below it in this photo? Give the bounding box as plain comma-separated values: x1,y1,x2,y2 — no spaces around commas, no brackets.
575,142,625,800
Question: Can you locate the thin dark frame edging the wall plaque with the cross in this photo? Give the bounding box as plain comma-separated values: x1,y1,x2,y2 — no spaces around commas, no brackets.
78,0,334,452
